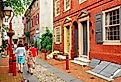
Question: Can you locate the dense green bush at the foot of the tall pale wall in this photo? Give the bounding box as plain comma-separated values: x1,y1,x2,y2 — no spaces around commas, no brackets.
40,27,52,50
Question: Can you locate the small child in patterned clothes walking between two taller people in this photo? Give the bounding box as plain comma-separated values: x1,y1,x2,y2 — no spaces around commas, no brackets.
27,51,34,75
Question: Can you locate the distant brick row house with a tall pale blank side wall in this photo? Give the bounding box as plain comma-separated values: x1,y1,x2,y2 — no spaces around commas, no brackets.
24,0,53,42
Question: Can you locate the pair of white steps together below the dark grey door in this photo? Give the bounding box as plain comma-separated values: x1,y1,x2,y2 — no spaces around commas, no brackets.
71,57,90,66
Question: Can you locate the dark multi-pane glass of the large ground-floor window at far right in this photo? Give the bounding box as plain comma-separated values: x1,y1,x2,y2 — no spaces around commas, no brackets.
105,9,120,40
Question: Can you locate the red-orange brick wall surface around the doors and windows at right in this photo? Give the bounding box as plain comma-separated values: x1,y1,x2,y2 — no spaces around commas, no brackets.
54,0,121,64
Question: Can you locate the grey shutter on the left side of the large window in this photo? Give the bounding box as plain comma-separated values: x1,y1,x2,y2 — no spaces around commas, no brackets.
96,12,103,43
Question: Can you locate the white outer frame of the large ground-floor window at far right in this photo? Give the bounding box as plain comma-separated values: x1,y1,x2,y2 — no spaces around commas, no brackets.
102,6,121,45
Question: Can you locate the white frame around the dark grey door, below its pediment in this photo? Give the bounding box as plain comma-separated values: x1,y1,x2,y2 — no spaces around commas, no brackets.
78,16,90,58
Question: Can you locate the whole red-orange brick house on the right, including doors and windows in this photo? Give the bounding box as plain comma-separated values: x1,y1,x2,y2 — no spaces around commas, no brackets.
53,0,121,64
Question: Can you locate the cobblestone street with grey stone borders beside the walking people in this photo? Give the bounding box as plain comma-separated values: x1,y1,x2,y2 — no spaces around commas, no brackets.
23,58,81,82
